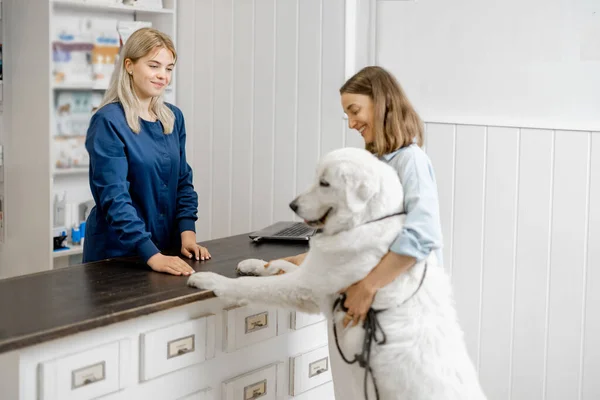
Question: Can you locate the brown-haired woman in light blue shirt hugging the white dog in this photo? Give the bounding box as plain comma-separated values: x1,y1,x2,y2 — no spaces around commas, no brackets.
287,66,442,325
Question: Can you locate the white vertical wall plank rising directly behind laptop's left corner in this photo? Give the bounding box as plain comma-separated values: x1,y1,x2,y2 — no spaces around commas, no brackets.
250,0,281,230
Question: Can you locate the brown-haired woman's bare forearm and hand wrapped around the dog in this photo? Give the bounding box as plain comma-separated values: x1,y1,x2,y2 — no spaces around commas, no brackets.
341,251,416,327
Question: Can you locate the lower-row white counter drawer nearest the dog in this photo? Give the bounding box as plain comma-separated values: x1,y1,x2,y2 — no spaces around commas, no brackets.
290,346,331,396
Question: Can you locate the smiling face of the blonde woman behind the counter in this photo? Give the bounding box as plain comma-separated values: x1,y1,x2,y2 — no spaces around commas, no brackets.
125,47,175,101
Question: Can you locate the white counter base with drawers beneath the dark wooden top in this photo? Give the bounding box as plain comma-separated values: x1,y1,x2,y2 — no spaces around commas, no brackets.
0,298,334,400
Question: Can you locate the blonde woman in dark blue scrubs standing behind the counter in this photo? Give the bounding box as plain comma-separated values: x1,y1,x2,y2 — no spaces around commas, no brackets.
83,28,211,275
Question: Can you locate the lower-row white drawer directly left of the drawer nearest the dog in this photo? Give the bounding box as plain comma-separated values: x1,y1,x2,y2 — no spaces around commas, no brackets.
221,364,281,400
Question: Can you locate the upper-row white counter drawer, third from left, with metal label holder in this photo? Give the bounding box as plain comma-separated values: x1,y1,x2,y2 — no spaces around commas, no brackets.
223,307,277,352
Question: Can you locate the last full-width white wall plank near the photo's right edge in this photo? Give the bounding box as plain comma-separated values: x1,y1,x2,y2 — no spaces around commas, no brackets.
545,131,589,400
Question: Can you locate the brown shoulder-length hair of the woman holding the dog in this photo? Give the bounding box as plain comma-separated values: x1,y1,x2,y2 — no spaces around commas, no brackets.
340,66,423,156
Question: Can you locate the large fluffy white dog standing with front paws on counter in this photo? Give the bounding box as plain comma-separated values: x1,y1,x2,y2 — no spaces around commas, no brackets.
188,148,485,400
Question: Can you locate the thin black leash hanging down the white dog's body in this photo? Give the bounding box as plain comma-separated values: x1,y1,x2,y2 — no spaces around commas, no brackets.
332,212,427,400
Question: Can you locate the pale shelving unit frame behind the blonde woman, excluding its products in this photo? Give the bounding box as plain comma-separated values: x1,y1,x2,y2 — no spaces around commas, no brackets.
0,0,177,276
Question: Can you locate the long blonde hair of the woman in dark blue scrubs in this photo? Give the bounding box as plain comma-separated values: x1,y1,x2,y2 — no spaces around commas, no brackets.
98,28,177,134
